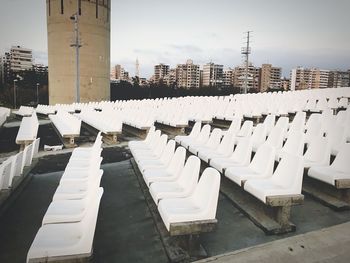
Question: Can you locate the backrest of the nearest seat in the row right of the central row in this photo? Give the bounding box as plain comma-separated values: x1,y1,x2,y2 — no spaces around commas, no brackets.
272,153,304,194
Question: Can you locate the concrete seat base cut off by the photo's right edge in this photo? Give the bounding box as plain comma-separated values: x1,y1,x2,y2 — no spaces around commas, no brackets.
303,176,350,211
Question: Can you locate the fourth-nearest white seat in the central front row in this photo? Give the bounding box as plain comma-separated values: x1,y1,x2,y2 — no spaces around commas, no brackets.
137,140,176,171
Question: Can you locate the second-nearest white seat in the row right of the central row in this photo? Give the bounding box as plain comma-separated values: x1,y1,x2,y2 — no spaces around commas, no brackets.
225,144,276,186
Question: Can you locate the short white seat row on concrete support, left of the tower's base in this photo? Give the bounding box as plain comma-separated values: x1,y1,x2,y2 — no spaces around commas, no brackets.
16,112,39,149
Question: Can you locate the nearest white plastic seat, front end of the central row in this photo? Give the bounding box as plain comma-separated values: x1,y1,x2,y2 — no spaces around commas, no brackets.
158,168,220,231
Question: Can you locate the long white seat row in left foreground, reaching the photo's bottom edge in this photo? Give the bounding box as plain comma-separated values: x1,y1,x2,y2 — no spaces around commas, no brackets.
27,133,103,262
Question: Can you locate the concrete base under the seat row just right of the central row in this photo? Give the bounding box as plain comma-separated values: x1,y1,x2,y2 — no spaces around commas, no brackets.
220,176,303,235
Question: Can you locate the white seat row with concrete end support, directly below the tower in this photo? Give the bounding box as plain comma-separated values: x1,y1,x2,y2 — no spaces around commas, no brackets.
49,111,81,148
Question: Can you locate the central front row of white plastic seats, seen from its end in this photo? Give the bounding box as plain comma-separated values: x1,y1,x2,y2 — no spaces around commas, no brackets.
129,127,220,231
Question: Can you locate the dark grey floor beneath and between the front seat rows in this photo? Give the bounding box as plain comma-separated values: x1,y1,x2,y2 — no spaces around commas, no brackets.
0,147,350,263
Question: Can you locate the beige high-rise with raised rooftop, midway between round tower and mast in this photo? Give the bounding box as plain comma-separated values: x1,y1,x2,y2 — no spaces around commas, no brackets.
176,59,199,89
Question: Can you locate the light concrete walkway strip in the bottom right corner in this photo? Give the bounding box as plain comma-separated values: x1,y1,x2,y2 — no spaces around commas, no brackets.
197,222,350,263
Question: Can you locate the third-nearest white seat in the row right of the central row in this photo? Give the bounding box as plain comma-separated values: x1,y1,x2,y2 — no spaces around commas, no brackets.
210,138,253,173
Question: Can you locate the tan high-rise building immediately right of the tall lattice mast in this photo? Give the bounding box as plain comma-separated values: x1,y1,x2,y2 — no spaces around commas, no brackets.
259,64,282,92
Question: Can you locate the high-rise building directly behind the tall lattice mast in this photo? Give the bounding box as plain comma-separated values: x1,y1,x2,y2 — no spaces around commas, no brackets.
233,63,260,90
